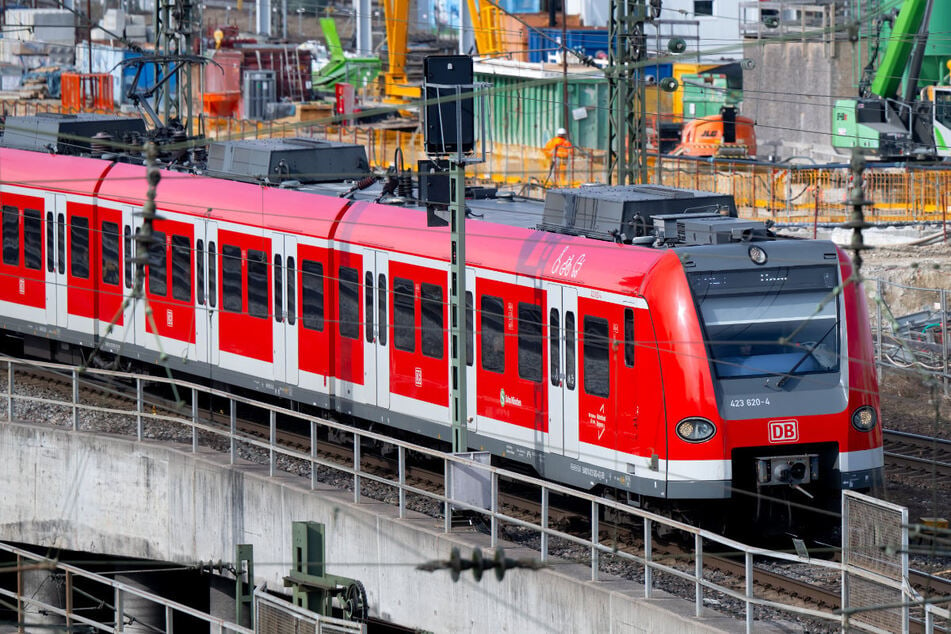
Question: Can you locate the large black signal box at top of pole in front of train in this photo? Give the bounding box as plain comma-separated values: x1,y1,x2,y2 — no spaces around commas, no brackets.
423,55,475,154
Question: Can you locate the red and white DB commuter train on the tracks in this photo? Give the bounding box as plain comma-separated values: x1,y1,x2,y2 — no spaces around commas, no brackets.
0,116,884,524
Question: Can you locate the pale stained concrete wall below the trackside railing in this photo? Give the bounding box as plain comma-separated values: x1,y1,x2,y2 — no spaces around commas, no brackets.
0,423,760,634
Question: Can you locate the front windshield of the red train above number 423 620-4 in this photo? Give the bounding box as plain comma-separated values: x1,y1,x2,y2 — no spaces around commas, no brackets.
687,266,840,379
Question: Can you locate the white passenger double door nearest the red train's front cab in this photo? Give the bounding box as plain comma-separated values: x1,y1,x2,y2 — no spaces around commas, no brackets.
545,282,579,458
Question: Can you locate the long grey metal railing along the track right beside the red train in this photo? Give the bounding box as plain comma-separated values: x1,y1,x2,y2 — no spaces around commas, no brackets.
0,359,924,632
